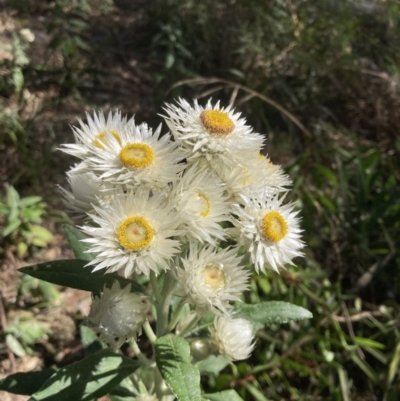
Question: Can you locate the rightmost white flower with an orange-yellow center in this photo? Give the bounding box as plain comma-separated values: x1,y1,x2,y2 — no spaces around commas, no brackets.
233,194,304,273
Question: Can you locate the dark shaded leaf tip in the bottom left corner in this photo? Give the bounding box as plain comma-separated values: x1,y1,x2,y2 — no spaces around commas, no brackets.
0,369,56,395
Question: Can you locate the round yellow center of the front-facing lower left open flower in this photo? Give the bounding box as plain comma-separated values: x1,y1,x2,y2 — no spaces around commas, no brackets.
117,216,154,251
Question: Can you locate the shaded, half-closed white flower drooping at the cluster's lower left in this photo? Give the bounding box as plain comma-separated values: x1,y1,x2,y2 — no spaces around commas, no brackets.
87,281,146,347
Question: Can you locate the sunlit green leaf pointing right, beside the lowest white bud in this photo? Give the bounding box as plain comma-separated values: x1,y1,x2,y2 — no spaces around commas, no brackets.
234,301,312,330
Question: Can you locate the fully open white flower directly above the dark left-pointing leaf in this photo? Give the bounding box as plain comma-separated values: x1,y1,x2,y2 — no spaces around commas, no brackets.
82,189,181,277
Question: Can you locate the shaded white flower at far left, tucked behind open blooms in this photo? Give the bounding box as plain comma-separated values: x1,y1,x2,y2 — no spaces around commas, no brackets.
59,170,106,218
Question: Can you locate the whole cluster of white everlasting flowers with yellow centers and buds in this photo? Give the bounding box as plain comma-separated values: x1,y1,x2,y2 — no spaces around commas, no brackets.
61,99,303,360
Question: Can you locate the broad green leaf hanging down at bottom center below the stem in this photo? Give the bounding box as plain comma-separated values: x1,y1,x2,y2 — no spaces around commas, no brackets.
156,334,201,401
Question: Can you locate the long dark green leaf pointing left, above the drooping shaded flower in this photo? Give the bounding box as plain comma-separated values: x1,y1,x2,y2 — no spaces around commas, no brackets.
19,259,144,293
